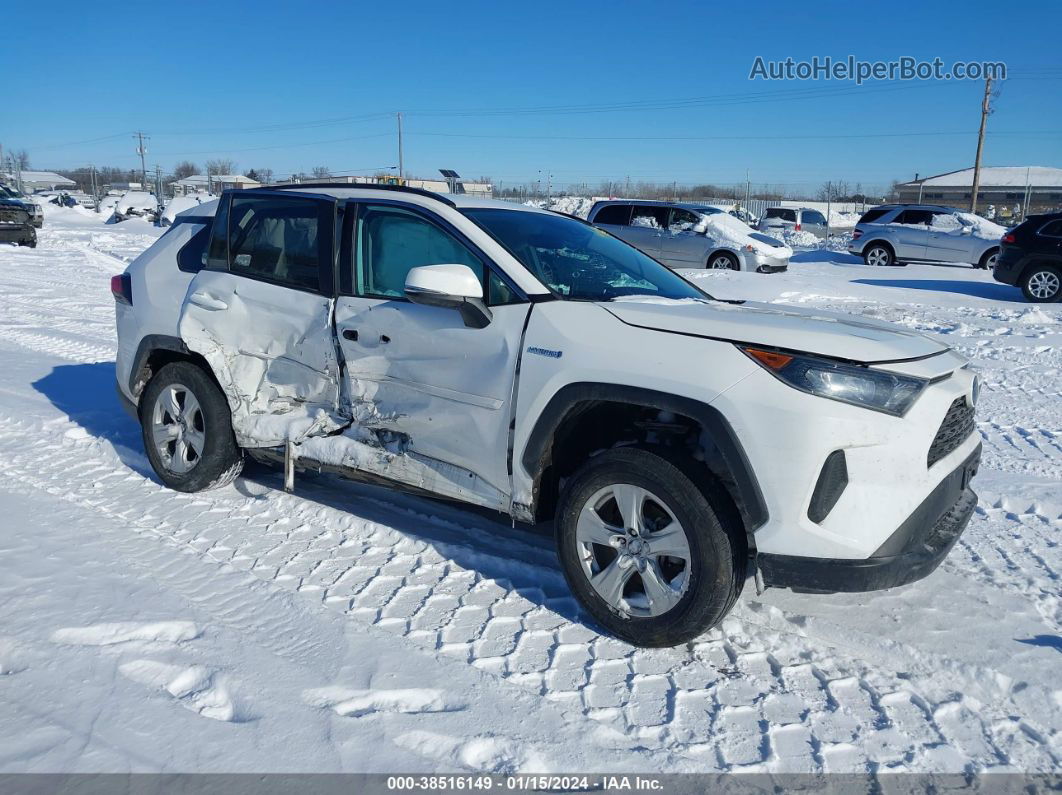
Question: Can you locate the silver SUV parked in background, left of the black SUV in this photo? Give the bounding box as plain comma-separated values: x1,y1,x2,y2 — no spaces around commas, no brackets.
849,204,1007,269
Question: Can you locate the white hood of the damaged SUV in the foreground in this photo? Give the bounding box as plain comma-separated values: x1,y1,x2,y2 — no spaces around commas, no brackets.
600,296,948,364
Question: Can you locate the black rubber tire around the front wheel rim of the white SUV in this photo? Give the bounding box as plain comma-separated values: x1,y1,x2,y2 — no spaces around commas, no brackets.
555,447,744,646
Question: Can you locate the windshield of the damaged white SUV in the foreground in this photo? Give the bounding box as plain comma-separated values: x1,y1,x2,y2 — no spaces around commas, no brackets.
464,209,710,300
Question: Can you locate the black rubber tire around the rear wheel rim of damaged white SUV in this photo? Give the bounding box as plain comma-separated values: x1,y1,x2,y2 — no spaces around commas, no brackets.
138,362,243,491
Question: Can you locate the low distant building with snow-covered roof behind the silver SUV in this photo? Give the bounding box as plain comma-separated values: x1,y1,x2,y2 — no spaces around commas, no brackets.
897,166,1062,215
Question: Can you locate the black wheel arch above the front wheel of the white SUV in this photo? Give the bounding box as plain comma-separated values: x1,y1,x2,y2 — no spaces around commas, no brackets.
520,382,768,554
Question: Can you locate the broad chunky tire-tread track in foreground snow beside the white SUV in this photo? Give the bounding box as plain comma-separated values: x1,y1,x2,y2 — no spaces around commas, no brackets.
0,403,1057,770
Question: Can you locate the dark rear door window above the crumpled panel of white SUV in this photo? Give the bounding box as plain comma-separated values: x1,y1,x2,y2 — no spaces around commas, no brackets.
228,196,331,292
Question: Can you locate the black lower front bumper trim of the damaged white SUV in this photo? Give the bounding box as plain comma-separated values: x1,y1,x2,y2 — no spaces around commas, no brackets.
756,445,981,593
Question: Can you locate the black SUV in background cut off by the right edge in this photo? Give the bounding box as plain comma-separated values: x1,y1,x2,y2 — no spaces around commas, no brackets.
992,212,1062,304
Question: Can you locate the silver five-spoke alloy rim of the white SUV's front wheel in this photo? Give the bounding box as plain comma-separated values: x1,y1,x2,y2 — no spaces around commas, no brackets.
576,483,692,618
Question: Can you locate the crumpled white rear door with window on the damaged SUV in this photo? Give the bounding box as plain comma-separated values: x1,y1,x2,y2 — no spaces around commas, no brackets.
174,191,346,447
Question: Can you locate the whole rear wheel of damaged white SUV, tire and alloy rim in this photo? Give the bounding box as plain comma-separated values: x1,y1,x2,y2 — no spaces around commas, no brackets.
140,362,243,491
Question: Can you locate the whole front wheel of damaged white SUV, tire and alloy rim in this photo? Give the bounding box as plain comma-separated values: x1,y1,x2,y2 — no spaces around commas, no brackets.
556,448,744,646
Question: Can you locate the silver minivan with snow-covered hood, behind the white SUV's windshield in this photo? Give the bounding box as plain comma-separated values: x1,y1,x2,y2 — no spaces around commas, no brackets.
587,201,792,273
